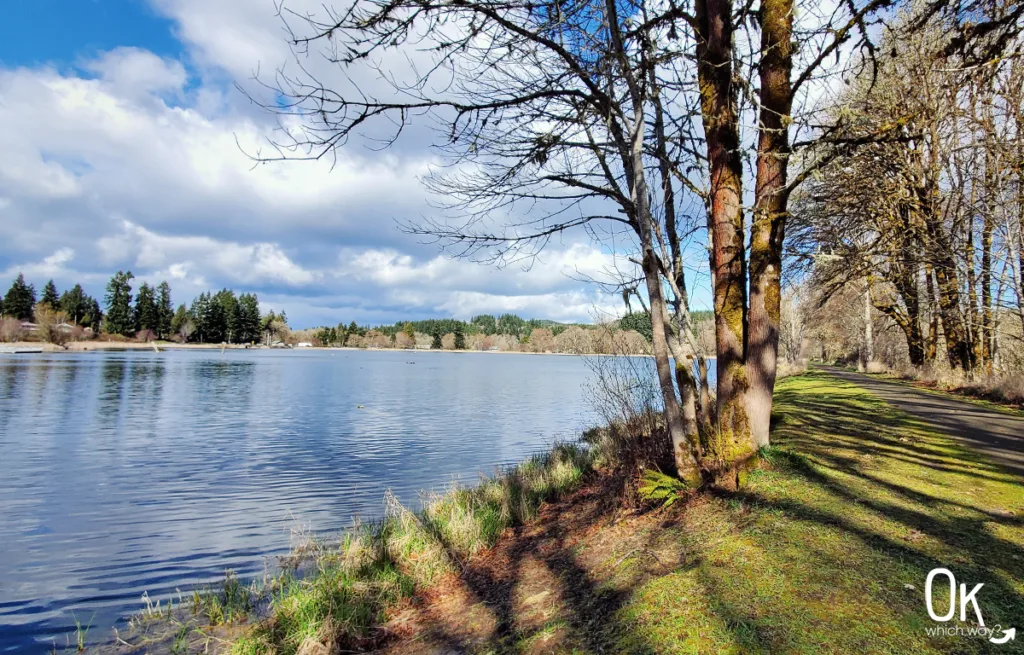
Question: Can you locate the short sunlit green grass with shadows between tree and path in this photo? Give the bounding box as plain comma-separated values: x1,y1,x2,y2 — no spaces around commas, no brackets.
617,373,1024,655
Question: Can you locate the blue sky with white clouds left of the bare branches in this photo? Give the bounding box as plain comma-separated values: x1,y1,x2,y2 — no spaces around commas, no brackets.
0,0,700,328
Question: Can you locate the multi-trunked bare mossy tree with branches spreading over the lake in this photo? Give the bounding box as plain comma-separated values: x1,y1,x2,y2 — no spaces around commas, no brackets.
249,0,1022,485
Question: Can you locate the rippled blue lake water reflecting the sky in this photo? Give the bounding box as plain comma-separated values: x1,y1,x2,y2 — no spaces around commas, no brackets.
0,350,596,652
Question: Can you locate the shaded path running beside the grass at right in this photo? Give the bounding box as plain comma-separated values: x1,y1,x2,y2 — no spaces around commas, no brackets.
821,366,1024,478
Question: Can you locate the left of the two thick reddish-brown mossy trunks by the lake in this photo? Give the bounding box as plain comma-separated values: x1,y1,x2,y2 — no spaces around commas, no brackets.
695,0,757,486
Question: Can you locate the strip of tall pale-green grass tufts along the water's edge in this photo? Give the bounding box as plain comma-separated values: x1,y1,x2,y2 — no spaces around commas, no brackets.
231,444,597,655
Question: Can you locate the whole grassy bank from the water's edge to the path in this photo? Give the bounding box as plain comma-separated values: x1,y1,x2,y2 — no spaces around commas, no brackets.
108,373,1024,655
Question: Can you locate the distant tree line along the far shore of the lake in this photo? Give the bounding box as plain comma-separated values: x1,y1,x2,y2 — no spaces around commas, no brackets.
0,271,714,354
